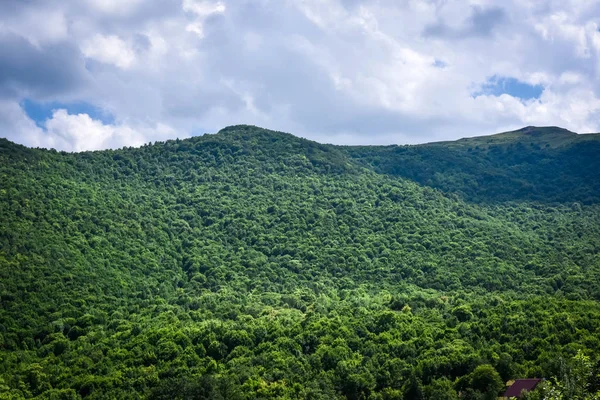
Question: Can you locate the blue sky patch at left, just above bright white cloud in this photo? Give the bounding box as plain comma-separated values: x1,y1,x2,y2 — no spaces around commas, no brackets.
20,99,115,128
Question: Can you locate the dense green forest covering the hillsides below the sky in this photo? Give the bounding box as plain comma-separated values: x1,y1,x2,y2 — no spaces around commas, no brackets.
0,125,600,400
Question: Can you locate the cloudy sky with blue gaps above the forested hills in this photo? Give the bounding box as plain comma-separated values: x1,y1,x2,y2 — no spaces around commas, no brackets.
0,0,600,151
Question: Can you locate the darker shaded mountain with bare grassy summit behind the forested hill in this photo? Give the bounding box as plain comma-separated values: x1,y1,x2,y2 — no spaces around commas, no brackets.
348,127,600,204
